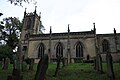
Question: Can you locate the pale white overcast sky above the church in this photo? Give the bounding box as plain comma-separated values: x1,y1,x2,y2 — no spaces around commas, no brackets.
0,0,120,34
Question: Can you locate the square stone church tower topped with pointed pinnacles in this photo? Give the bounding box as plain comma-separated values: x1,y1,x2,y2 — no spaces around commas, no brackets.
20,7,42,57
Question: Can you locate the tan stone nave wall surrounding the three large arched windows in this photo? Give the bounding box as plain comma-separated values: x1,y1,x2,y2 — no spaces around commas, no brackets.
28,34,95,59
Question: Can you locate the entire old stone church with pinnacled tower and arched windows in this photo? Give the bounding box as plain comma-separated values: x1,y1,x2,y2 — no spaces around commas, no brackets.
20,9,120,63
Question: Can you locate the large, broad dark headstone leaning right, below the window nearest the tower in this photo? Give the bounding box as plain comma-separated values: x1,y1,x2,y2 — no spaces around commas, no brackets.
34,54,48,80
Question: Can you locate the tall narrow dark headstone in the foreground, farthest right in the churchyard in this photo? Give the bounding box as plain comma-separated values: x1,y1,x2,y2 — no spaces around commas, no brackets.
106,53,115,80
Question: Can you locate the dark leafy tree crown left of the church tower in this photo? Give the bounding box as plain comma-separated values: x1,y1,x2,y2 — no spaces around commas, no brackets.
0,17,22,49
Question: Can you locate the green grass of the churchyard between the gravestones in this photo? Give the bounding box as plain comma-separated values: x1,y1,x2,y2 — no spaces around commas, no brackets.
0,63,120,80
